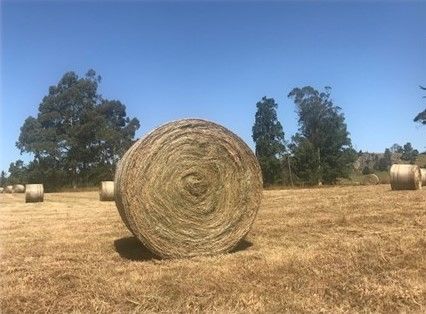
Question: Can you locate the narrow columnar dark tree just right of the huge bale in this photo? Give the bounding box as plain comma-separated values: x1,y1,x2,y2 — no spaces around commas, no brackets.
252,97,285,185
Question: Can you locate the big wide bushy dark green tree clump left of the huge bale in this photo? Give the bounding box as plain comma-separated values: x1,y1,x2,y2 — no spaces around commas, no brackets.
16,70,139,187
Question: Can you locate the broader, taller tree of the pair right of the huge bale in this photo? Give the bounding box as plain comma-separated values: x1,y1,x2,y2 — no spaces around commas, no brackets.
288,86,357,184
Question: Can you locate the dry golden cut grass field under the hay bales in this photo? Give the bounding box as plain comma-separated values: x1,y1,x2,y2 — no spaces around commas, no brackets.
0,185,426,313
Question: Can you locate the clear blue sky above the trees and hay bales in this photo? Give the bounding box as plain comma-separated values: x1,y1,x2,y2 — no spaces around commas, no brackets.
0,1,426,170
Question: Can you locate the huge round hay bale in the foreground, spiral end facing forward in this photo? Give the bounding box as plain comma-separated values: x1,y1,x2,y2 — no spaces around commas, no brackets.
115,119,262,258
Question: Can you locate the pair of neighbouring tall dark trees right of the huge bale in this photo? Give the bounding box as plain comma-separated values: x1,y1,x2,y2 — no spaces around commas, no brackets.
253,86,357,185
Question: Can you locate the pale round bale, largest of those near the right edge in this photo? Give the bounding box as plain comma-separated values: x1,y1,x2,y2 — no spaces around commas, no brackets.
390,164,422,190
